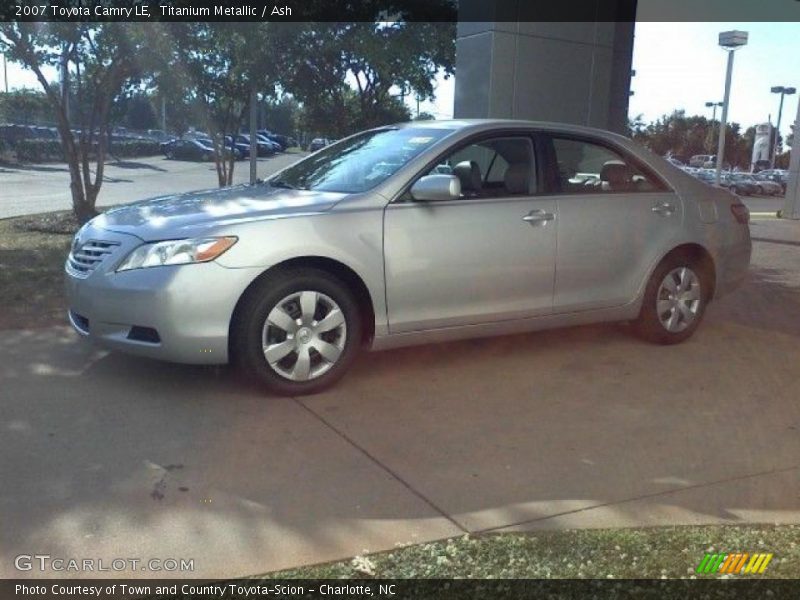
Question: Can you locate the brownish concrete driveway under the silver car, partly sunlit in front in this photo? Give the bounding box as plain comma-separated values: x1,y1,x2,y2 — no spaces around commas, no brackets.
0,219,800,578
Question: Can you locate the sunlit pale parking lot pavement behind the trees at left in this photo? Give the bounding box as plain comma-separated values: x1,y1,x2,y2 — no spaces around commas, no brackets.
0,152,305,219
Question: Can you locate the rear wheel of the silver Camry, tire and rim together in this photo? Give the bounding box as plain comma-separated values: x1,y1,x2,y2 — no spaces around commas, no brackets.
633,254,711,344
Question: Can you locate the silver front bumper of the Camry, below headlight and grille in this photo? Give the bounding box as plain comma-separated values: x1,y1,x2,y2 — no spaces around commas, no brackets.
65,231,263,364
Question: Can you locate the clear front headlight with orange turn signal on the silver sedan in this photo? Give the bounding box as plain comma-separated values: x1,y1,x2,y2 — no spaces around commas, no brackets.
117,236,238,271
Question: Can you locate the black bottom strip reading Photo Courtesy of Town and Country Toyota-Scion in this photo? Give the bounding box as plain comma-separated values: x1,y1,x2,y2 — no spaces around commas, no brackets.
0,577,800,600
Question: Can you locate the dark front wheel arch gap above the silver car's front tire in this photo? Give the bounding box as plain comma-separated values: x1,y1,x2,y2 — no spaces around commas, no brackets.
228,256,375,355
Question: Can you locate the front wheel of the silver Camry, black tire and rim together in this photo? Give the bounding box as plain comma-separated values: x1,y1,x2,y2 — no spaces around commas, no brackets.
231,268,363,396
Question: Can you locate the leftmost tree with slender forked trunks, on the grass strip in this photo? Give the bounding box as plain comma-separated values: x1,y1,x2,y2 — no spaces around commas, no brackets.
0,22,148,223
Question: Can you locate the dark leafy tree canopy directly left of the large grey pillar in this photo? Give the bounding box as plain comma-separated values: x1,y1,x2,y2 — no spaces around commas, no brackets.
285,20,455,137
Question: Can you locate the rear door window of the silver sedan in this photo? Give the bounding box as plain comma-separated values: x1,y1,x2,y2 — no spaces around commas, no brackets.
552,137,665,194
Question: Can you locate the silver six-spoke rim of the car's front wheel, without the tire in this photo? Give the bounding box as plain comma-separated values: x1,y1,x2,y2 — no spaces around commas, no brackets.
261,290,347,381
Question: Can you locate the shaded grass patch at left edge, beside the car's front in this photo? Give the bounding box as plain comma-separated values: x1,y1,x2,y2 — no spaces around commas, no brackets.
0,212,77,329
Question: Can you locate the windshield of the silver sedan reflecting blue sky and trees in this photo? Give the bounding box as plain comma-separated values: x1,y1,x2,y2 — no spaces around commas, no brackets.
268,127,452,194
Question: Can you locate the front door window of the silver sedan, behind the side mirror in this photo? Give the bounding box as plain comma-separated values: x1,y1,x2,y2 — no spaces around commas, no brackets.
418,137,536,198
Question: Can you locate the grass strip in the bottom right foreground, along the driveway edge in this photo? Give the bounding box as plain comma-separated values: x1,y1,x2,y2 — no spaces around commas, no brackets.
265,525,800,579
